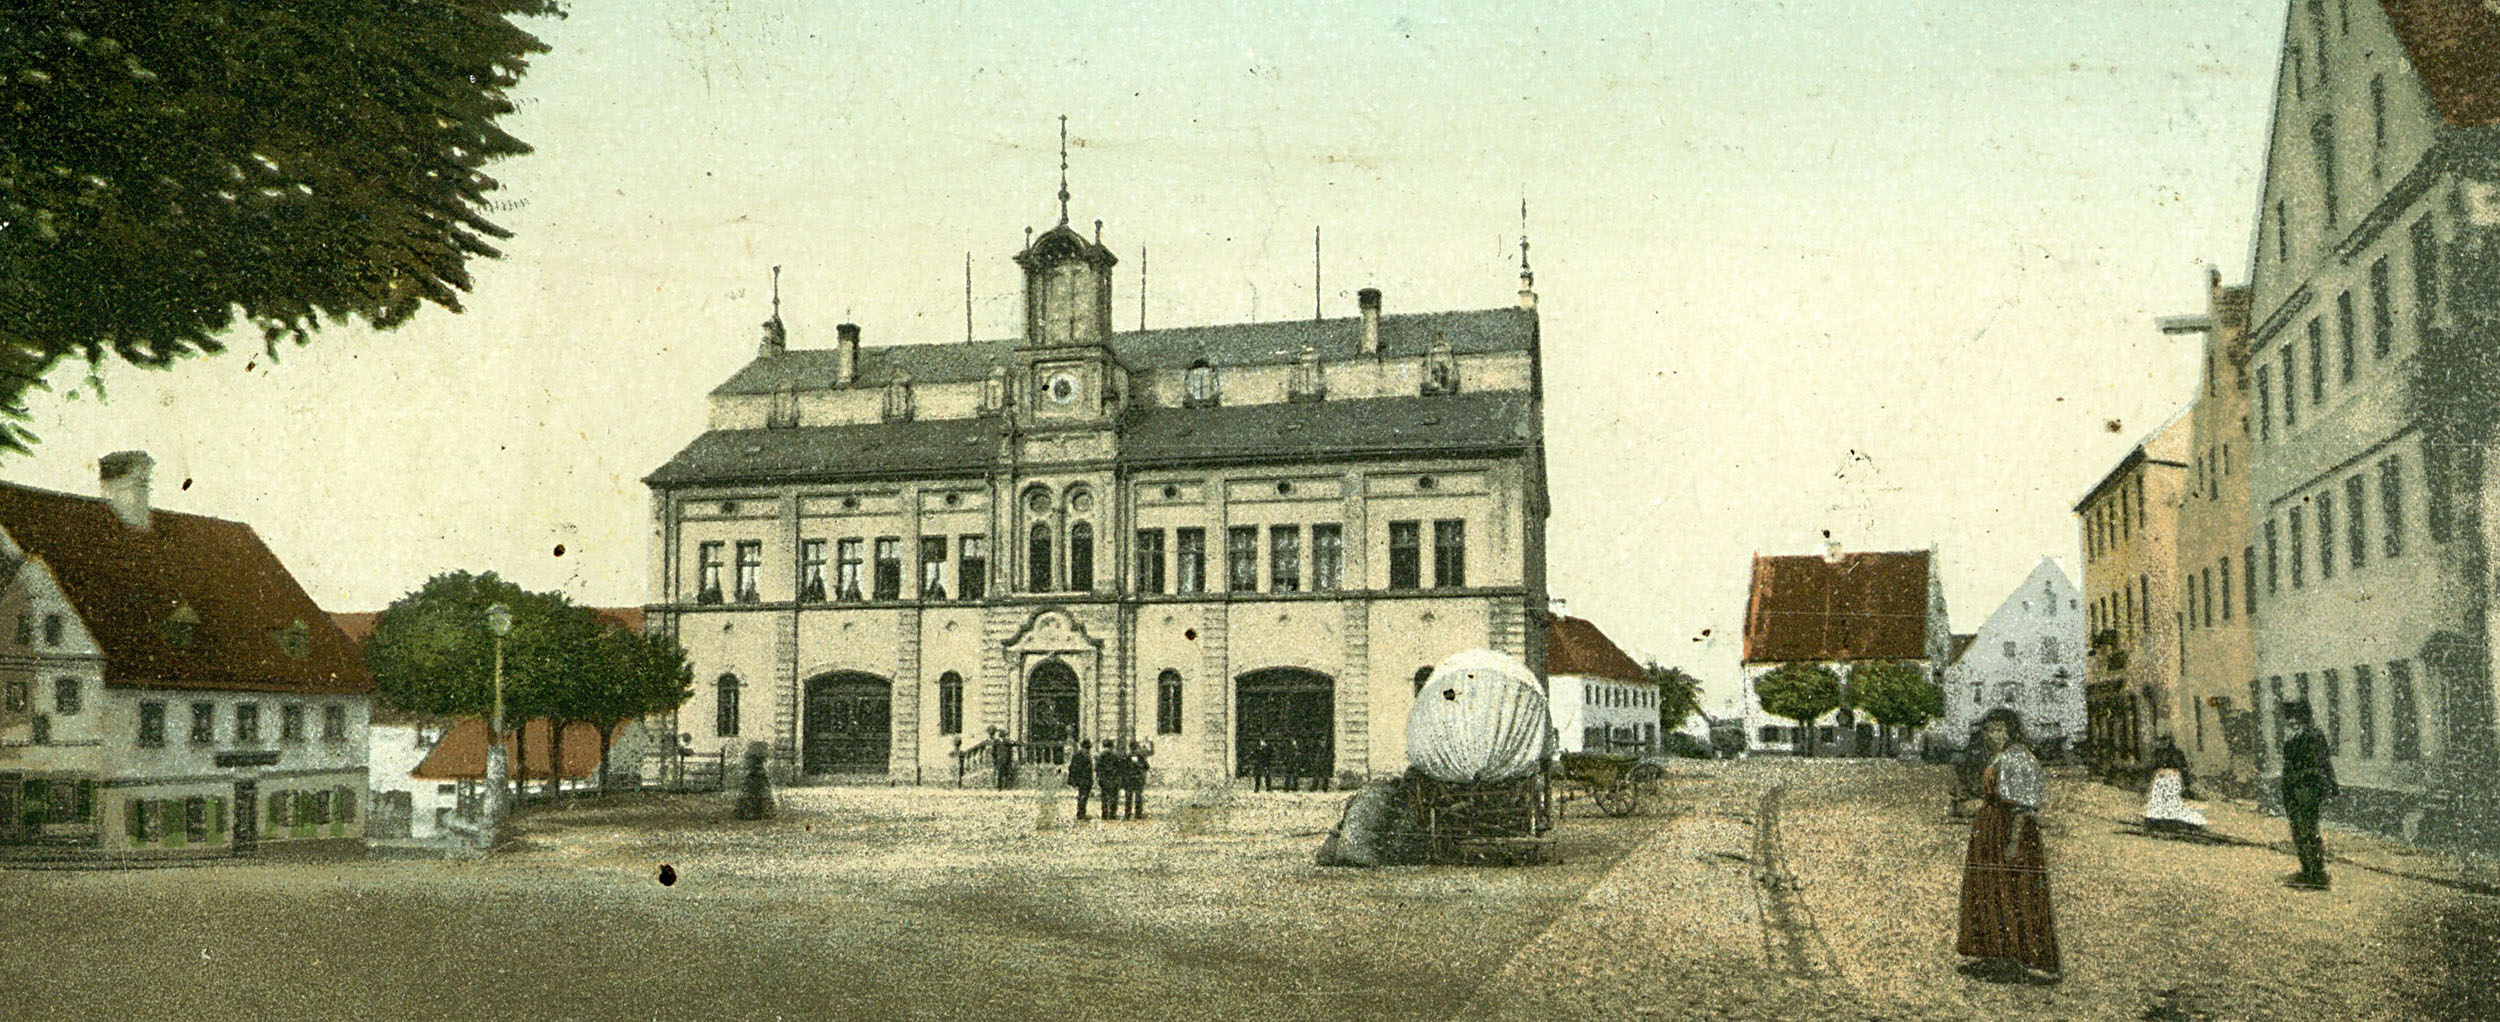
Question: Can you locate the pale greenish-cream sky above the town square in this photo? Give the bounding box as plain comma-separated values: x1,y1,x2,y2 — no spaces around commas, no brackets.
0,0,2283,705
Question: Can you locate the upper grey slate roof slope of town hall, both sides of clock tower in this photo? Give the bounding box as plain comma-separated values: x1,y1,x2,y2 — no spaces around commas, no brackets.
713,307,1538,397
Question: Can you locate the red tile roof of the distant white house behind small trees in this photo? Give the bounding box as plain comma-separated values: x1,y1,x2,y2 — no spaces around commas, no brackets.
1745,550,1930,665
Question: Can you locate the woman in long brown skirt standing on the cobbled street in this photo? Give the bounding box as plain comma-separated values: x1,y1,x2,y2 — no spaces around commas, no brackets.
1955,707,2060,982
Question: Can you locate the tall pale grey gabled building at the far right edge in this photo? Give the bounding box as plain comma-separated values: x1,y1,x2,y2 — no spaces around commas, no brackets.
2248,0,2500,837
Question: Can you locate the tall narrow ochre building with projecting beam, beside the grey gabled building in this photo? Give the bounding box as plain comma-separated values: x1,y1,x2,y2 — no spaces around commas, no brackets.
2160,272,2260,792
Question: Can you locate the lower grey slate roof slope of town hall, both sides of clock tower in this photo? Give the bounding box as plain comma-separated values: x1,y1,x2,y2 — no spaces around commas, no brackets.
643,390,1535,485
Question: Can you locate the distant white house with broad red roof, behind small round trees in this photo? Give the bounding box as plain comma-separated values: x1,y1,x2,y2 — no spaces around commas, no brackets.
1745,542,1953,755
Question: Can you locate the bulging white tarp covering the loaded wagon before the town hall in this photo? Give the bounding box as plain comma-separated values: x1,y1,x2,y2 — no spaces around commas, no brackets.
1408,650,1553,785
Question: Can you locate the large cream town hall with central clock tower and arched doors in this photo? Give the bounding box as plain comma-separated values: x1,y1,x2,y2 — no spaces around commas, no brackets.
645,184,1545,782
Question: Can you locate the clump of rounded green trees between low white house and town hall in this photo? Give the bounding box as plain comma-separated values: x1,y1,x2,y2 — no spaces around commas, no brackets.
365,572,693,790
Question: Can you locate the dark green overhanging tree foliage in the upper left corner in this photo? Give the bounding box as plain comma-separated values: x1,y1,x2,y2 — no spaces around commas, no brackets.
0,0,560,450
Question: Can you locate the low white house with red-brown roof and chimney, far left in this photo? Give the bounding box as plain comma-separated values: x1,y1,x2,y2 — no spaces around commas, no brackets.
0,452,373,855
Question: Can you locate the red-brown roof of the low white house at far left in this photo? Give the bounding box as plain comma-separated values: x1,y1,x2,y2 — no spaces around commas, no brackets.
0,482,373,695
